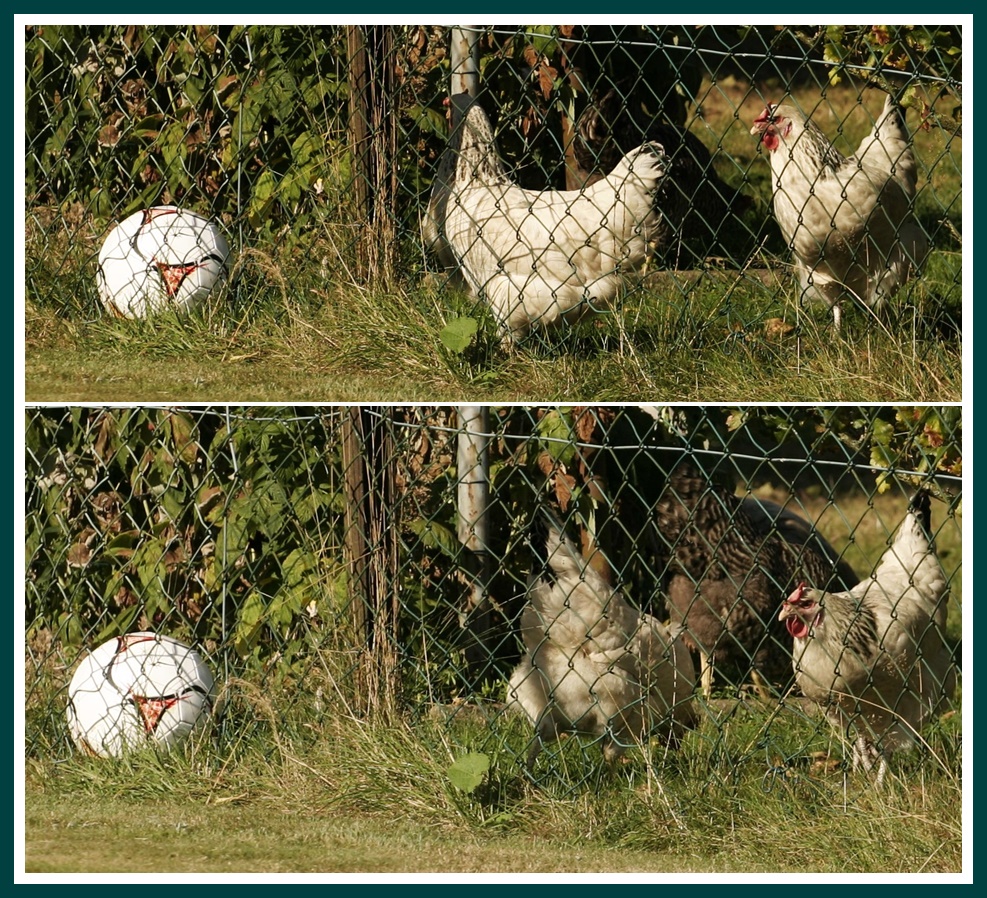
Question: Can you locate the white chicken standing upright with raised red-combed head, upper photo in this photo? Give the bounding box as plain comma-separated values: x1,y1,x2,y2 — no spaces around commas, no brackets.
751,95,929,329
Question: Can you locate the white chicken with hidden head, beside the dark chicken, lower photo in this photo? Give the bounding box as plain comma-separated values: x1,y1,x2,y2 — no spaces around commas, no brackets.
508,512,698,769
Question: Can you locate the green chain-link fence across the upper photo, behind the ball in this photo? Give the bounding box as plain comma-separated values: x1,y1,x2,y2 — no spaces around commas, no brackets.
24,25,962,340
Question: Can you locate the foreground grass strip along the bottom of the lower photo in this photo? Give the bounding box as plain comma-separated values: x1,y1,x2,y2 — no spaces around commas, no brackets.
25,672,963,874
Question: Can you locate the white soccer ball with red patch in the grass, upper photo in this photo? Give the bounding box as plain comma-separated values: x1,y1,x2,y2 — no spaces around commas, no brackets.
96,206,230,318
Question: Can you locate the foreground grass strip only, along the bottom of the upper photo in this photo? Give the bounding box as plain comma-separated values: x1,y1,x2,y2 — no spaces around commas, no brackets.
25,256,962,402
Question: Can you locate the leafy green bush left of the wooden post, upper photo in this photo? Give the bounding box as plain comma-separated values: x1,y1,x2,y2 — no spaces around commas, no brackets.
26,25,347,236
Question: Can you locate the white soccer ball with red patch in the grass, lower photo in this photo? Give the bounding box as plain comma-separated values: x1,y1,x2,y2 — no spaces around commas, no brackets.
66,632,214,758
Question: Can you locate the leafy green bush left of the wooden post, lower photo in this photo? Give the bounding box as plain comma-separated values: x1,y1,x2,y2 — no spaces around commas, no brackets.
26,408,346,670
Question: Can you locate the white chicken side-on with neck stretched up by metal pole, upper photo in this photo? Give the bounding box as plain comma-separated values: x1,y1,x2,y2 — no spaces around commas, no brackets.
423,94,668,344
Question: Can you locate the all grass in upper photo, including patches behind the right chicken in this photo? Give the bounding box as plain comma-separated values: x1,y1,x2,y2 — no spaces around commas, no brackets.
25,81,963,402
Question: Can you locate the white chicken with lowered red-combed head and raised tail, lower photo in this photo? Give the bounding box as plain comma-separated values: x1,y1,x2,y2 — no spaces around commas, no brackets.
778,491,956,785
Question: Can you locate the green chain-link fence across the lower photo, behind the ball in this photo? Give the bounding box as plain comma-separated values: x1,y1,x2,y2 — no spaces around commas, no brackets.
24,406,962,790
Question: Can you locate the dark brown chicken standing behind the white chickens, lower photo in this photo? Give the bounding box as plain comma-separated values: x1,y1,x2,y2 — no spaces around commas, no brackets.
654,459,858,696
